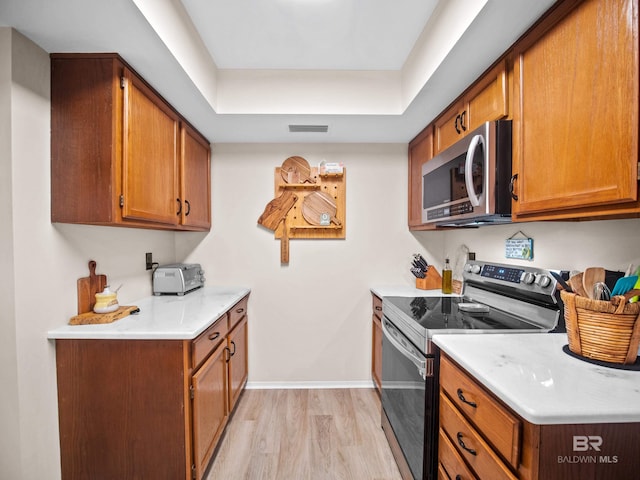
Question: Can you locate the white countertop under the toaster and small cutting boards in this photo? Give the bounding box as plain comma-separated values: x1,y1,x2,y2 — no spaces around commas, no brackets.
47,287,250,340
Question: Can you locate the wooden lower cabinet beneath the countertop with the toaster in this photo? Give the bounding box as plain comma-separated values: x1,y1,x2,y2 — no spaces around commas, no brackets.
56,297,248,480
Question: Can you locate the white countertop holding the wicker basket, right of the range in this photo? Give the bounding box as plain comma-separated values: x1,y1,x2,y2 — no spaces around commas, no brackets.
433,333,640,425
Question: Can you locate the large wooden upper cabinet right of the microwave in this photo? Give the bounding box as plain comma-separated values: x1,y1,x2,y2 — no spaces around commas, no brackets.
513,0,640,220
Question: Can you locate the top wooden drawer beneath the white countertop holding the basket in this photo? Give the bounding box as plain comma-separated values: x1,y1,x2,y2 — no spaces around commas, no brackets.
440,355,521,468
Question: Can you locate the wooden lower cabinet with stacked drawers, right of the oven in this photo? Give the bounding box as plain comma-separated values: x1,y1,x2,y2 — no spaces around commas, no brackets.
438,354,640,480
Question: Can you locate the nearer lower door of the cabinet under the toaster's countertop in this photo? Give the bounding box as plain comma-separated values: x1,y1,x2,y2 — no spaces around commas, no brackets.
192,342,229,480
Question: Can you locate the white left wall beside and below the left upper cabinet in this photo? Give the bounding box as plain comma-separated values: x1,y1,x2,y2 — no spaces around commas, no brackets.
0,28,175,480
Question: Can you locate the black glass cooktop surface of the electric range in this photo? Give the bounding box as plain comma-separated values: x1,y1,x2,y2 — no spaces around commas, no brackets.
384,297,540,333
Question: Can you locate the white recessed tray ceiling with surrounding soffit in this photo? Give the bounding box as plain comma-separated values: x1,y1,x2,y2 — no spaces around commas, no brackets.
0,0,555,143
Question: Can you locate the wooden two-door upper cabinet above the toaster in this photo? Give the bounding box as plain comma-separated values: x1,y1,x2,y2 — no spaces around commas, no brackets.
51,54,211,231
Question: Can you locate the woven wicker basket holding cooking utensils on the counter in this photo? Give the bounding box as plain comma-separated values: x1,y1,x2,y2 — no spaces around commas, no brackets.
560,290,640,364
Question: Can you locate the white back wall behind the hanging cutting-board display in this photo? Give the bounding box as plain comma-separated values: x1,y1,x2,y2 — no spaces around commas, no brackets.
176,144,442,386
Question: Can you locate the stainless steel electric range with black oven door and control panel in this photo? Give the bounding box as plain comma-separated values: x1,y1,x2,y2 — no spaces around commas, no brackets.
382,261,564,480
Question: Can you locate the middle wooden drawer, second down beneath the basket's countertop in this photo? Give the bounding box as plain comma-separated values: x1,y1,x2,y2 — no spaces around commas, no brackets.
440,394,516,480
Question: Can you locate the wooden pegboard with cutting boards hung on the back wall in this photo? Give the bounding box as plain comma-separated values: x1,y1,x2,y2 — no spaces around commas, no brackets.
258,156,347,263
